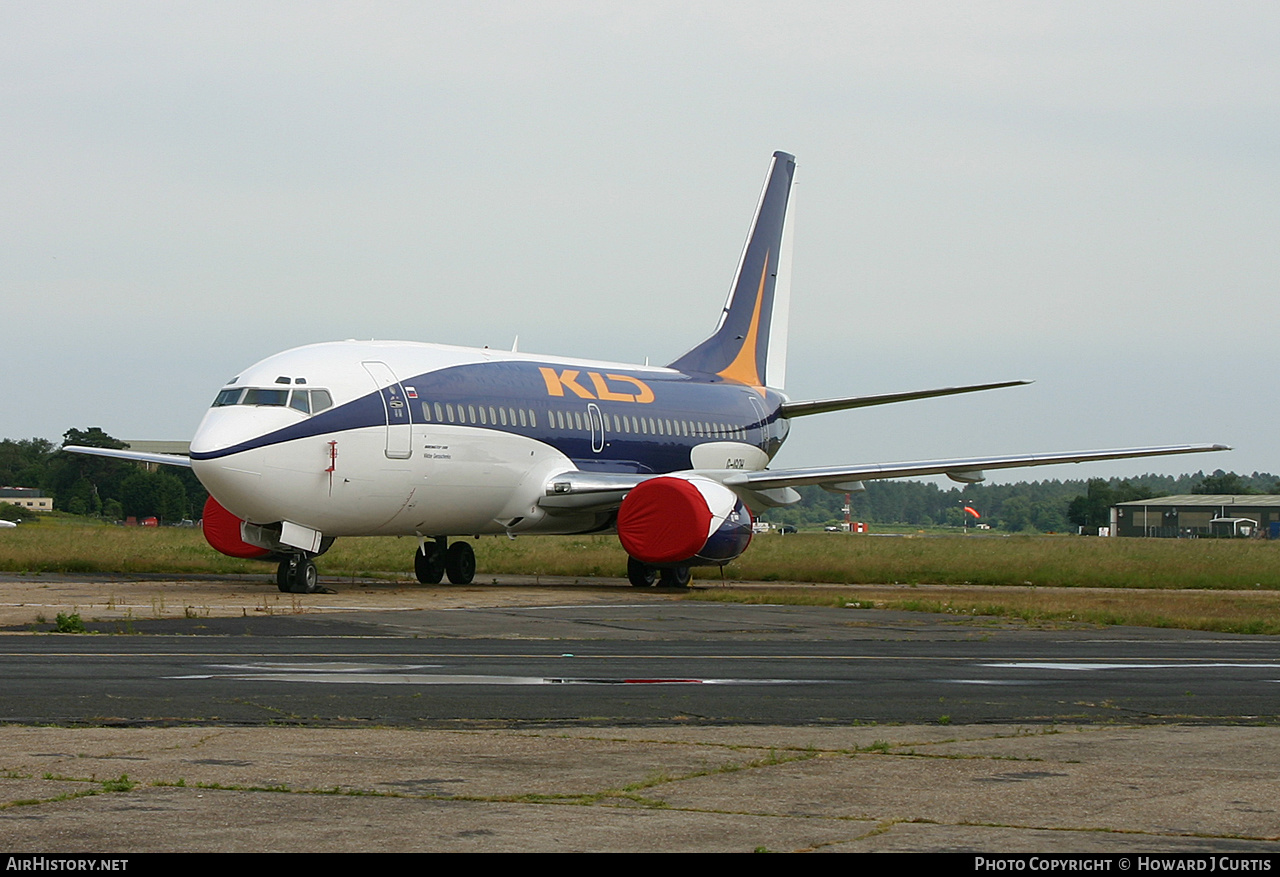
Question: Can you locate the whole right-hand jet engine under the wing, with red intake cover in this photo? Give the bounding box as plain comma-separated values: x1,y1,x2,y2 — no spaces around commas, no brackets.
617,475,751,566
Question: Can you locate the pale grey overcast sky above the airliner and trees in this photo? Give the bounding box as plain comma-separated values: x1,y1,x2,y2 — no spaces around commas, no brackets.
0,0,1280,479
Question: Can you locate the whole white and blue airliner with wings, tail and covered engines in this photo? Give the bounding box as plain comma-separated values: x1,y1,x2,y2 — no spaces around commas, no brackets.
65,152,1228,593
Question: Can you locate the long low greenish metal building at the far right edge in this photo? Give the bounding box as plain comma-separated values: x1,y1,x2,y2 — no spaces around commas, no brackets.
1111,493,1280,539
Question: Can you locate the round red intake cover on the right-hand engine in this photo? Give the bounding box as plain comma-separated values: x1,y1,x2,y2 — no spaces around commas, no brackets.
617,478,713,563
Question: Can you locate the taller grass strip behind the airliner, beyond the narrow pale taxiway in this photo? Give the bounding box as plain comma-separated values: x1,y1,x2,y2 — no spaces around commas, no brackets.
0,524,1280,590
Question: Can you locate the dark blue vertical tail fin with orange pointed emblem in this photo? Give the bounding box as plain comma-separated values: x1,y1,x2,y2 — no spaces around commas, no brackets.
671,152,796,389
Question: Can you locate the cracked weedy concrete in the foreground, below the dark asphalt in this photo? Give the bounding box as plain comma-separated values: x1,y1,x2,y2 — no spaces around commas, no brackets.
0,725,1280,854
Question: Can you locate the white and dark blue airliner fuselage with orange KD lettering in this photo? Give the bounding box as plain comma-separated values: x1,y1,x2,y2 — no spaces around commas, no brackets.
191,342,769,536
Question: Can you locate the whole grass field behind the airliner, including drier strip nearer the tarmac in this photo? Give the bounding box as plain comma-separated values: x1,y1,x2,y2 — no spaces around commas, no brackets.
0,517,1280,634
